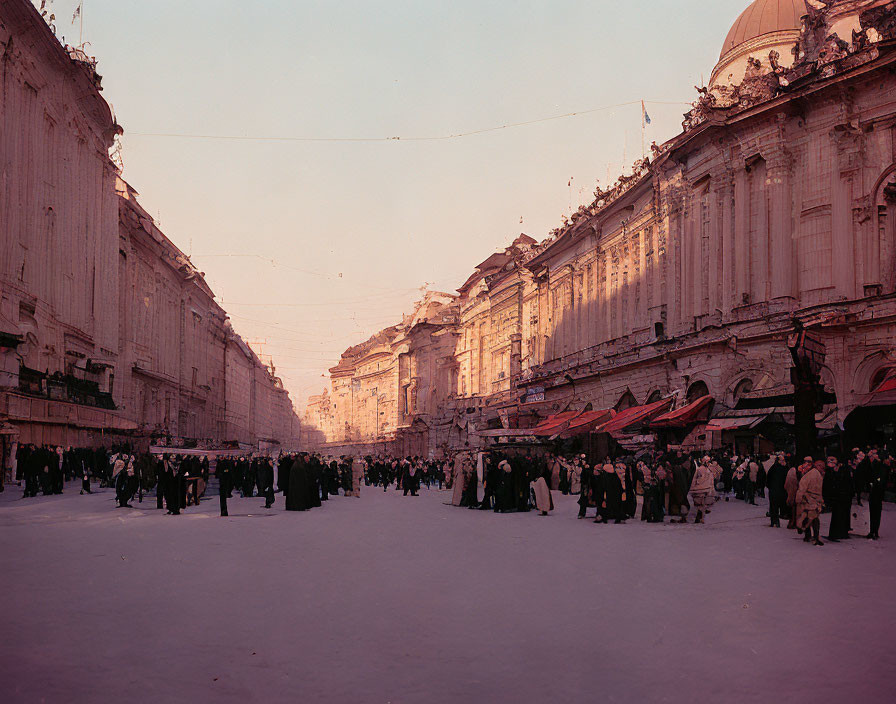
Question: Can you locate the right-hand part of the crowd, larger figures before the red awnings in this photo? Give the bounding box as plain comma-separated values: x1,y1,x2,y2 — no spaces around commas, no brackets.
450,447,894,545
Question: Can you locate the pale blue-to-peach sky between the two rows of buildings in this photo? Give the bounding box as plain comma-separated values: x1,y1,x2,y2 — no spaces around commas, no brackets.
45,0,749,413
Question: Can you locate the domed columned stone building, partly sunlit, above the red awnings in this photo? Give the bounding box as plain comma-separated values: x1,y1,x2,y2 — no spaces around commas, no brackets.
314,0,896,454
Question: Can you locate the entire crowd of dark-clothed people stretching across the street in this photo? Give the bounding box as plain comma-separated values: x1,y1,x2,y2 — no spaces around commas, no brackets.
0,445,896,545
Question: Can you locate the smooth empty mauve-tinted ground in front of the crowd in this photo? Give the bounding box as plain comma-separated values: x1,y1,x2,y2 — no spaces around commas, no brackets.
0,484,896,704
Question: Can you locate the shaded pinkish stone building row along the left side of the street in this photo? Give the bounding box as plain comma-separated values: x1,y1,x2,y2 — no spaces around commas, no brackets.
0,0,299,459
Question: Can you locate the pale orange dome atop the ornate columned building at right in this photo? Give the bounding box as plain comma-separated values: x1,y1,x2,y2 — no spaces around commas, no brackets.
710,0,806,86
